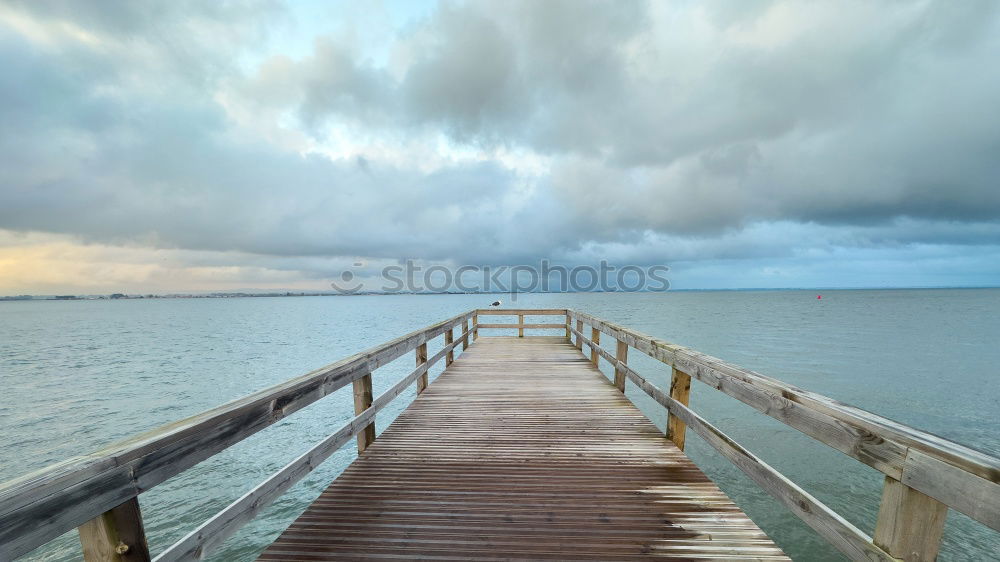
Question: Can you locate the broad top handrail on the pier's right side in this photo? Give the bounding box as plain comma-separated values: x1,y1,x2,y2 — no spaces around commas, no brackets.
567,310,1000,530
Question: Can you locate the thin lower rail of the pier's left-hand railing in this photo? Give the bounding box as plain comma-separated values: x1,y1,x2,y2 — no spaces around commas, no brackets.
154,333,468,562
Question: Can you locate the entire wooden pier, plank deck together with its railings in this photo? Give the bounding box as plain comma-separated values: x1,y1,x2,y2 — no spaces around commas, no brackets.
0,309,1000,562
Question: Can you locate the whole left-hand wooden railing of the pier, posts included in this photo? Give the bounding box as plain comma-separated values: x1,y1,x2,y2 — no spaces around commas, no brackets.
0,311,474,562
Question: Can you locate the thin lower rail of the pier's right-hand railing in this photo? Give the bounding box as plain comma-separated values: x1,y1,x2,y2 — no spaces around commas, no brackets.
627,358,895,562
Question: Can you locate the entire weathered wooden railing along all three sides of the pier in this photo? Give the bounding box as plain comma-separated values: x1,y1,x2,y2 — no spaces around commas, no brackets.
0,309,1000,561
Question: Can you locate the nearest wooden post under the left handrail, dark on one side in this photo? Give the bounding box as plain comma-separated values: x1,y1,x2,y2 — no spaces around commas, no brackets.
80,498,149,562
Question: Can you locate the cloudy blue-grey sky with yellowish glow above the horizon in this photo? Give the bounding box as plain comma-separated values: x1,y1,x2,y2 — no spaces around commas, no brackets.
0,0,1000,294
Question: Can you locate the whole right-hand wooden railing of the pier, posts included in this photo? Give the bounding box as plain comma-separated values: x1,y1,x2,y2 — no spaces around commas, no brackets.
566,310,1000,561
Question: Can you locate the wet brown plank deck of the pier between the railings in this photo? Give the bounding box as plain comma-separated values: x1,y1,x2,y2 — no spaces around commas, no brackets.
260,337,787,561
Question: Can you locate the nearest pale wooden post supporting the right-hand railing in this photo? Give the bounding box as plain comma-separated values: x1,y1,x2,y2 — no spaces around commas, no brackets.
873,476,948,562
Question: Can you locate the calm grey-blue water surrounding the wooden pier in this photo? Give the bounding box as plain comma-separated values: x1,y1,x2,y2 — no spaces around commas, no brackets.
0,289,1000,560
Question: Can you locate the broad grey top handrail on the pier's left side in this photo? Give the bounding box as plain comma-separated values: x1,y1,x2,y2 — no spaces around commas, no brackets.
0,311,475,560
